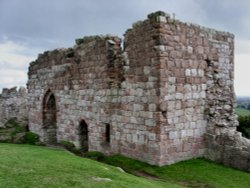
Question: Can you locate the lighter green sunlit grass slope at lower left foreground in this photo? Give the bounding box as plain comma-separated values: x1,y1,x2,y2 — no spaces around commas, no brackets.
0,144,181,188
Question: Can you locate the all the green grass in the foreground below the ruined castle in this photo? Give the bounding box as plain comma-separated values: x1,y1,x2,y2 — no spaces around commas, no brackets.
0,144,250,188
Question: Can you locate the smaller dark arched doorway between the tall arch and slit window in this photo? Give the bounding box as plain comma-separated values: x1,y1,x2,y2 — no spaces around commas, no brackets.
79,120,89,152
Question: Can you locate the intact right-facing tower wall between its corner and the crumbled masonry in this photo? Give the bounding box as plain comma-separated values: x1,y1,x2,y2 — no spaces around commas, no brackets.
151,14,210,164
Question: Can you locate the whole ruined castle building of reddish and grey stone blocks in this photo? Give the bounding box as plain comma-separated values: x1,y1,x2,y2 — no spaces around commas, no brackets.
0,12,250,170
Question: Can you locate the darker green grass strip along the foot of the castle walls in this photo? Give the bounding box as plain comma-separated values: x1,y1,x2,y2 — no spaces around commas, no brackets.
101,155,250,188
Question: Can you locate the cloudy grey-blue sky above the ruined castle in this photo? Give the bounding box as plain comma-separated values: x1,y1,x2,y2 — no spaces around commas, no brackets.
0,0,250,96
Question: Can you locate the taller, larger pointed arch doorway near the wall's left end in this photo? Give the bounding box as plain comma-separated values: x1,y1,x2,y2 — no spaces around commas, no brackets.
43,90,57,144
